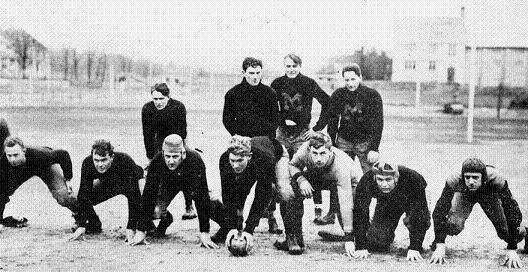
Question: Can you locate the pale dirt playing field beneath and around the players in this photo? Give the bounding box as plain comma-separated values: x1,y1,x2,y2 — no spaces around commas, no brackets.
0,108,528,271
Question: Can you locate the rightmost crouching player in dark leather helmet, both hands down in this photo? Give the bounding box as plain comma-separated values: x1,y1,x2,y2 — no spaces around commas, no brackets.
430,157,523,268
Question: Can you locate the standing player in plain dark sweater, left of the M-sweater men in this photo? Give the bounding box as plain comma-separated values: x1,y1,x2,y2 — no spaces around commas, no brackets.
222,57,282,233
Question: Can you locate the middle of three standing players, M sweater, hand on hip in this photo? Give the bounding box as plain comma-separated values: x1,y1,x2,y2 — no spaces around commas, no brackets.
271,54,330,223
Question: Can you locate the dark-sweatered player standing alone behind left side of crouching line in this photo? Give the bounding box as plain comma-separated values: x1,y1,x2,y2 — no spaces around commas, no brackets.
141,83,196,220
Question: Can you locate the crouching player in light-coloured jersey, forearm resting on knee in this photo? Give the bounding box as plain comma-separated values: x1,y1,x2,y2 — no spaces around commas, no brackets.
274,132,362,255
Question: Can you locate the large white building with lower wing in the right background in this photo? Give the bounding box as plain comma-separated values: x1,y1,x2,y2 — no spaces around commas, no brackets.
392,8,528,87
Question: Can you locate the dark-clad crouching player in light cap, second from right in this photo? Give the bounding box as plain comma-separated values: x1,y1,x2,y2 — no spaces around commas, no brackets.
346,161,431,262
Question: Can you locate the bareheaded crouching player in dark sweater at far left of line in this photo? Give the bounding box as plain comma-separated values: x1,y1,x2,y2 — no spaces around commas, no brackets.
0,136,77,227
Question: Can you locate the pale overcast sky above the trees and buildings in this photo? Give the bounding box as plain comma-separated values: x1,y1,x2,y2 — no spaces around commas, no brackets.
0,0,528,71
